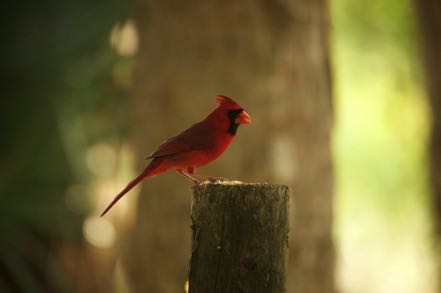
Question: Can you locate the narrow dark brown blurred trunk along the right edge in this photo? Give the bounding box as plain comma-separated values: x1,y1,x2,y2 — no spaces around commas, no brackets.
416,0,441,292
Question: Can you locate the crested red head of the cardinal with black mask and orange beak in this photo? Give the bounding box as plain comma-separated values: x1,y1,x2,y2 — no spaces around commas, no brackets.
216,95,251,135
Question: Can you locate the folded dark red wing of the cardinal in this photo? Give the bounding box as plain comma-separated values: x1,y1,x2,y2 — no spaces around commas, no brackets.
146,123,211,159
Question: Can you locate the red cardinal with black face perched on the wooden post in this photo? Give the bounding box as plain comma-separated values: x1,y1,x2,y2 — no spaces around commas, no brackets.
101,96,251,217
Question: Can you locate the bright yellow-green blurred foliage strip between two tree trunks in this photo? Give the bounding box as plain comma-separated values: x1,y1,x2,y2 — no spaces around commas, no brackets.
332,0,433,292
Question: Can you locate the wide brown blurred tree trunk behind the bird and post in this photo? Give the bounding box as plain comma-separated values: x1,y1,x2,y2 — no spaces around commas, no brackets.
127,0,334,293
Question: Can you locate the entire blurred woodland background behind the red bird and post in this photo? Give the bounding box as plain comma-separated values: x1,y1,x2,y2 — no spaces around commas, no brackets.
0,0,441,293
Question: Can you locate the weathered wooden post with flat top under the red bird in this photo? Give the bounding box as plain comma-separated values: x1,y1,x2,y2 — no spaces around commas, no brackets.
189,181,289,293
